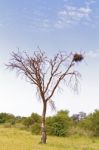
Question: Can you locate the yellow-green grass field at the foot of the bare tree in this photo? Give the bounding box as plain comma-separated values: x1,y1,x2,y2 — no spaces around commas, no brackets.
0,127,99,150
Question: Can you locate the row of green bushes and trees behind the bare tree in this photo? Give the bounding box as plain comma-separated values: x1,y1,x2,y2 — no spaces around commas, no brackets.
0,110,99,137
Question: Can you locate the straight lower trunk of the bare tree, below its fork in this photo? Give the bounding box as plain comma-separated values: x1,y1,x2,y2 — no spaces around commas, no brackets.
41,102,47,144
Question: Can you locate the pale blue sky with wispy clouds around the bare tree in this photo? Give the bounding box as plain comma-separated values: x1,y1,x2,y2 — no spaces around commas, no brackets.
0,0,99,115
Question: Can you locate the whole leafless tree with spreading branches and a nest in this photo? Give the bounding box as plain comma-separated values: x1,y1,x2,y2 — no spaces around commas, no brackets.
7,50,83,143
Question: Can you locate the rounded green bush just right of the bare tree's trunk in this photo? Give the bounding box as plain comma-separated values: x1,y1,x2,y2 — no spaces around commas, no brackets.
46,111,71,136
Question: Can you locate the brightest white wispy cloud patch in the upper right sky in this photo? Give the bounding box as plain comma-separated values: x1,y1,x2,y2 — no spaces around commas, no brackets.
56,6,92,27
